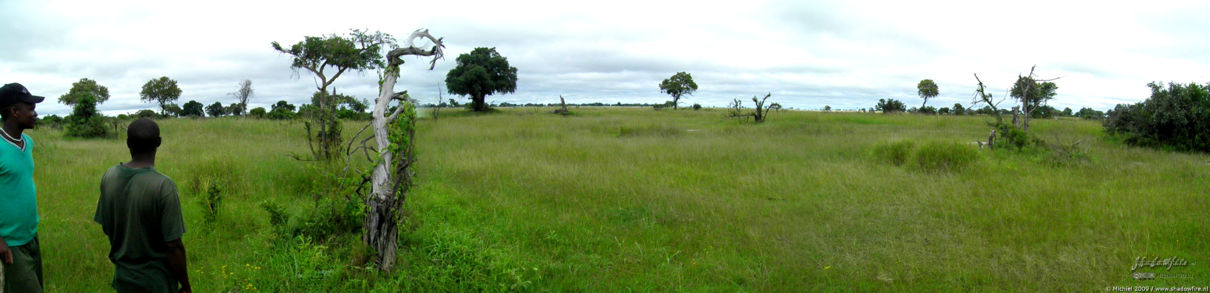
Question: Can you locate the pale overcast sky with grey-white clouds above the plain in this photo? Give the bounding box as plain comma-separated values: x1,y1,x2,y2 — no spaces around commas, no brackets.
0,0,1210,115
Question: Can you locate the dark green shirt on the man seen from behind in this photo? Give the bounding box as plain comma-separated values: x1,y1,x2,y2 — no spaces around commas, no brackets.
93,163,185,288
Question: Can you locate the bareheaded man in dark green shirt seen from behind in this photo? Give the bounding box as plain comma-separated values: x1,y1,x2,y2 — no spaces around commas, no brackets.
93,119,192,292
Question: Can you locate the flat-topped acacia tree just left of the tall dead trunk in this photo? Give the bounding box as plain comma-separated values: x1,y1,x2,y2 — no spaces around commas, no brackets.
272,29,394,160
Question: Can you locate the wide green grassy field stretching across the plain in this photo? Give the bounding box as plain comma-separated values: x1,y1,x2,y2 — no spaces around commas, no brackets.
30,108,1210,292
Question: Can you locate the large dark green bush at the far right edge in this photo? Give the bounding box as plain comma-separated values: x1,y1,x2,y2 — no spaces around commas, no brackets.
1105,82,1210,151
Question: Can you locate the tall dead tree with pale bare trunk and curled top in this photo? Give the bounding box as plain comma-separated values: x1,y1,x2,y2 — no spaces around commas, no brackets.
362,29,445,270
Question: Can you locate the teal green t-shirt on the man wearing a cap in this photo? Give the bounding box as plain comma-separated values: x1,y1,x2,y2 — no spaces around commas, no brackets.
0,133,38,246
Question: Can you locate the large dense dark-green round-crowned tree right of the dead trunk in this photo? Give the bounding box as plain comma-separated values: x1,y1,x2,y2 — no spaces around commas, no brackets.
445,47,517,111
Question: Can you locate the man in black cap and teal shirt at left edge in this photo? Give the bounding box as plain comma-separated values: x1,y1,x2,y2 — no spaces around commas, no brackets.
0,84,45,293
